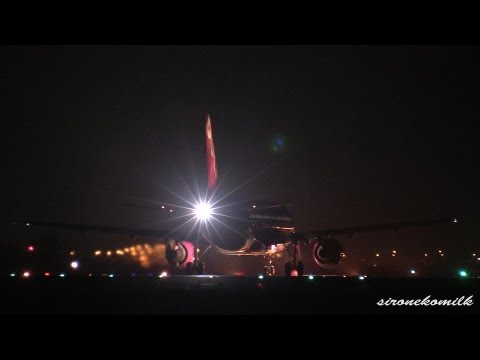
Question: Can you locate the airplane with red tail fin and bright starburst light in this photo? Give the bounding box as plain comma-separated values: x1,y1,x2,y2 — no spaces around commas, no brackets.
14,114,457,276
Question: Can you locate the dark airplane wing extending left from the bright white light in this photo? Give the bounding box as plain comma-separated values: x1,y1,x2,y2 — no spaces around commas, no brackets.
13,220,170,238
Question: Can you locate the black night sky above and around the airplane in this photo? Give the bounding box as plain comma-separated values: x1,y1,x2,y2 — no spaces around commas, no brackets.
0,46,480,276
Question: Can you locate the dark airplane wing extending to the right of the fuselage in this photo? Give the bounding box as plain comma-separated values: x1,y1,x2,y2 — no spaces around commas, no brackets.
295,218,458,239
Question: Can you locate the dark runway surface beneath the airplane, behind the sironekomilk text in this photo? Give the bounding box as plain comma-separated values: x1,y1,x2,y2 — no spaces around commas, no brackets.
0,274,480,315
